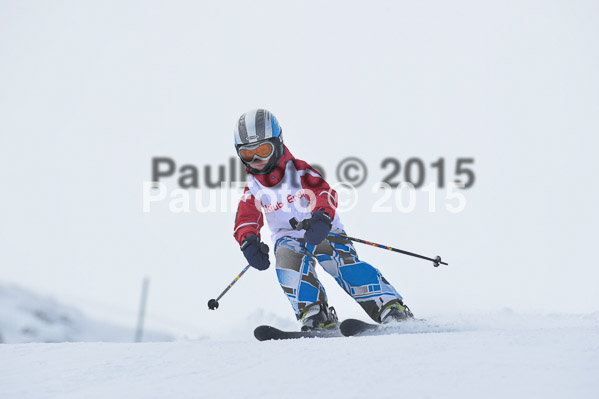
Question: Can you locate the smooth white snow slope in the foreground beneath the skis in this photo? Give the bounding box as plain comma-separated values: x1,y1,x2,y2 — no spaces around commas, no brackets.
0,312,599,399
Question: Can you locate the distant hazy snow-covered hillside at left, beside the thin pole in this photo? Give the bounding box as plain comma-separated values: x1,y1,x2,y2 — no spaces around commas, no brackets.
0,285,172,343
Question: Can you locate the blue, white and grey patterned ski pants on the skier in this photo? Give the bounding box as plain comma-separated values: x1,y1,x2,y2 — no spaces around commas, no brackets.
275,231,403,322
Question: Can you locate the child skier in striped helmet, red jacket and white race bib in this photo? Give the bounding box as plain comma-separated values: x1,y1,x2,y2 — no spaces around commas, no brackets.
234,109,412,331
